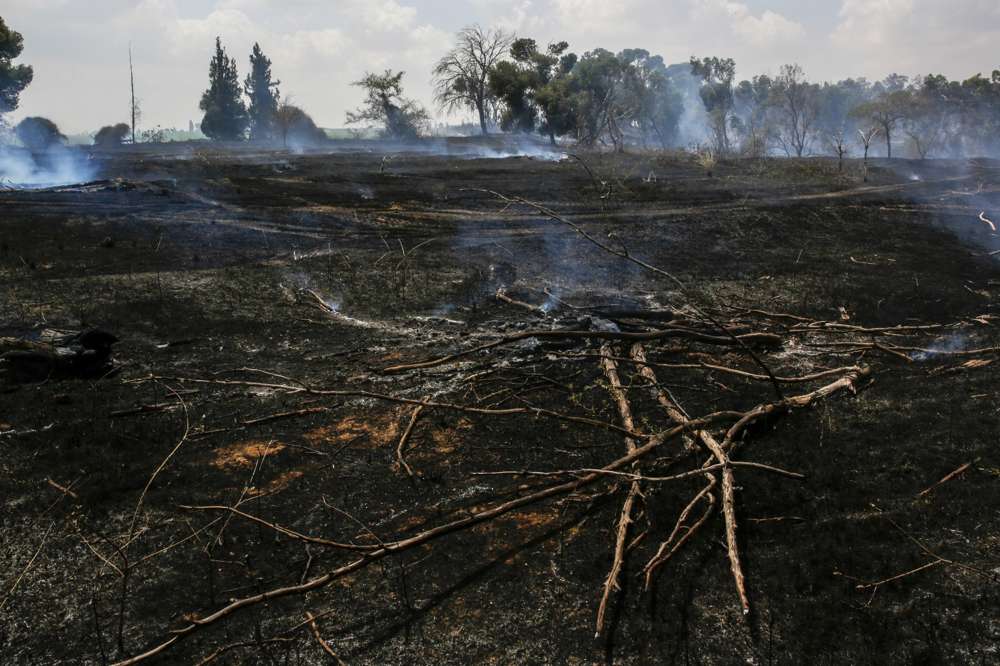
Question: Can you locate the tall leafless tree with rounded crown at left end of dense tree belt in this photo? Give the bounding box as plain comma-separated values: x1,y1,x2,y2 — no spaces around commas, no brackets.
434,25,514,134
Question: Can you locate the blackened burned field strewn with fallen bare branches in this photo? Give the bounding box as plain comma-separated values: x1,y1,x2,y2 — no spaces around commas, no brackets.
0,147,1000,664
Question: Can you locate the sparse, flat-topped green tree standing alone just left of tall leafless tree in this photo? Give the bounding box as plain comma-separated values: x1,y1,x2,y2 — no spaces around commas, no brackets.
347,69,429,139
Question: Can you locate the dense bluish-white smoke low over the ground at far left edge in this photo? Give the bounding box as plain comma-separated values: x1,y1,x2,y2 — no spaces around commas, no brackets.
0,144,96,189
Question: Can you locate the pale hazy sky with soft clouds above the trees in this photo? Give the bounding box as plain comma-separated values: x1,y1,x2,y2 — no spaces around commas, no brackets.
0,0,1000,132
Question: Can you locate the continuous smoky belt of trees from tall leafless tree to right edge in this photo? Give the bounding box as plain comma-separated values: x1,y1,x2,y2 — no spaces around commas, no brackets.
434,27,1000,160
